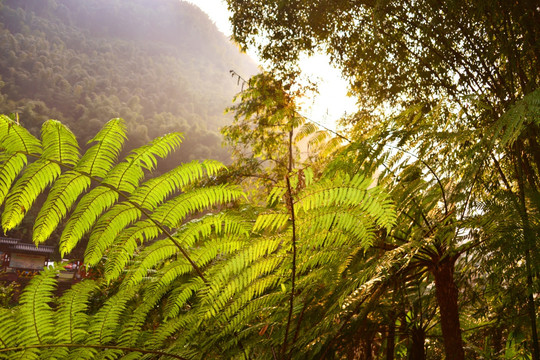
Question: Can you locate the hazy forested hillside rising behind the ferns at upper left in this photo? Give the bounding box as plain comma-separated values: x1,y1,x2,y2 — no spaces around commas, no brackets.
0,0,256,162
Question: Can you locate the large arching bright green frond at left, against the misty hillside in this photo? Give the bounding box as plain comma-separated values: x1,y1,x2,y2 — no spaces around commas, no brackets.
0,116,241,274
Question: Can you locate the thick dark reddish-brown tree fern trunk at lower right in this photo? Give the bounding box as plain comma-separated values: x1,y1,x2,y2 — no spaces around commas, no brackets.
432,258,465,360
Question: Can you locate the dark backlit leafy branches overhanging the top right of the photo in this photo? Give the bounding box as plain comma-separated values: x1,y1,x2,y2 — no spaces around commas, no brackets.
227,0,540,114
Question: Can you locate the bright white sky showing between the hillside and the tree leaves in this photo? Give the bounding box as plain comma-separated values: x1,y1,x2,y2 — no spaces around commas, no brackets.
185,0,356,130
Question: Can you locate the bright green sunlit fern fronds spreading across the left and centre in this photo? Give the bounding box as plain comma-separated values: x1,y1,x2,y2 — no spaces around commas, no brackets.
0,119,397,359
